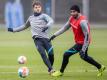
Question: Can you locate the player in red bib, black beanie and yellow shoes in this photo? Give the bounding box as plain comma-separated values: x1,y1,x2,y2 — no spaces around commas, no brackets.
50,5,105,76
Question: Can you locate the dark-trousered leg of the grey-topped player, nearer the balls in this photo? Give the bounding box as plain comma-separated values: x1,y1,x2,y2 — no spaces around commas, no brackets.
34,39,52,70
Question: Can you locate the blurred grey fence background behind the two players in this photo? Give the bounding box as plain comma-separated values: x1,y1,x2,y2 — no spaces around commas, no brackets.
0,0,107,24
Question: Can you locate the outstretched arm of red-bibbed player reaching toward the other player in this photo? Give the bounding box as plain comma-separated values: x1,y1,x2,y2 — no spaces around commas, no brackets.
50,21,70,41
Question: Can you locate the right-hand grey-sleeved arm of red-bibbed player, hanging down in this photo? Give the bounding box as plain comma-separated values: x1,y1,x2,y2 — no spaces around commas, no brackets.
80,20,89,52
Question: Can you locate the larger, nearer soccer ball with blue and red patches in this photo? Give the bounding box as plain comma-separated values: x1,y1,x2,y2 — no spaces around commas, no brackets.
18,67,29,78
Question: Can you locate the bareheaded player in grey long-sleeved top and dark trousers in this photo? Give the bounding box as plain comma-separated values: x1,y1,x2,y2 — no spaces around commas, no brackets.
8,1,54,73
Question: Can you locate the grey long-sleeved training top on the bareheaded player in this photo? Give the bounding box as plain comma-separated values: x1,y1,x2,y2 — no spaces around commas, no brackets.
13,13,54,38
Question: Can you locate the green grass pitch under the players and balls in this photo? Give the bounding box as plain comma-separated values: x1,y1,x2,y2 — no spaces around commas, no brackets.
0,29,107,80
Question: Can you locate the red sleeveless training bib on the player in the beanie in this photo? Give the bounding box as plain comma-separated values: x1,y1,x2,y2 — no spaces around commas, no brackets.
70,15,90,44
